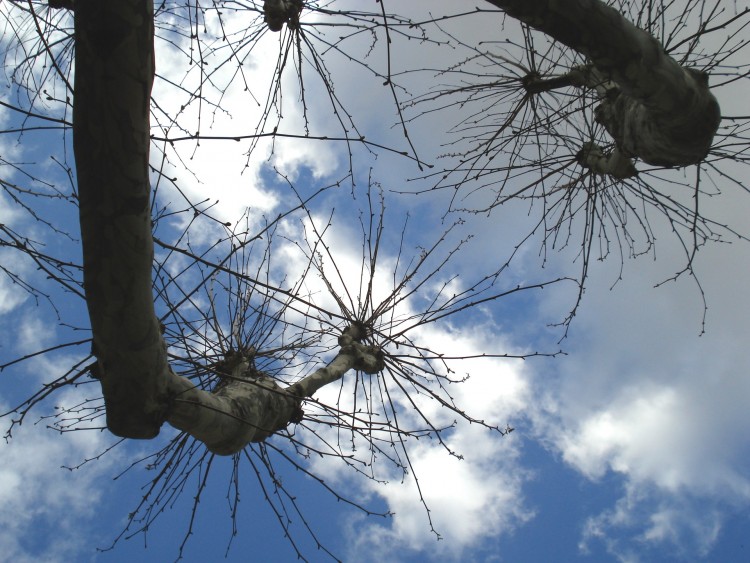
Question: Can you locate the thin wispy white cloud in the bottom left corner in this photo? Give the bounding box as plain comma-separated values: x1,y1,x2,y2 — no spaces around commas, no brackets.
0,390,120,563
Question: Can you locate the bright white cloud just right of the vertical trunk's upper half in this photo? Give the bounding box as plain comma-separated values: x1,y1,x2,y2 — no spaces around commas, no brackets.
151,11,340,230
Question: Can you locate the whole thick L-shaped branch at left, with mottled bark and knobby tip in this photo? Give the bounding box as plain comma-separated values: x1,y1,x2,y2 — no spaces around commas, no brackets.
73,0,383,455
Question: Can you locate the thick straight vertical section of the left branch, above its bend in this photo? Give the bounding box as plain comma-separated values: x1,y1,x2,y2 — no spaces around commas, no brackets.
73,0,170,438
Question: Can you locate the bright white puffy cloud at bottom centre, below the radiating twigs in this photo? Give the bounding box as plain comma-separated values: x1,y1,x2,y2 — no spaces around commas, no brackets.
347,430,532,561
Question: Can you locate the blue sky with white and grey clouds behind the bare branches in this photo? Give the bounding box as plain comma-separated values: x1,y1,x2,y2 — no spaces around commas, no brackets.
0,0,750,562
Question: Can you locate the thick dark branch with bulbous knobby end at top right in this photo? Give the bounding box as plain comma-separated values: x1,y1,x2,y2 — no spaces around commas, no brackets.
487,0,721,166
